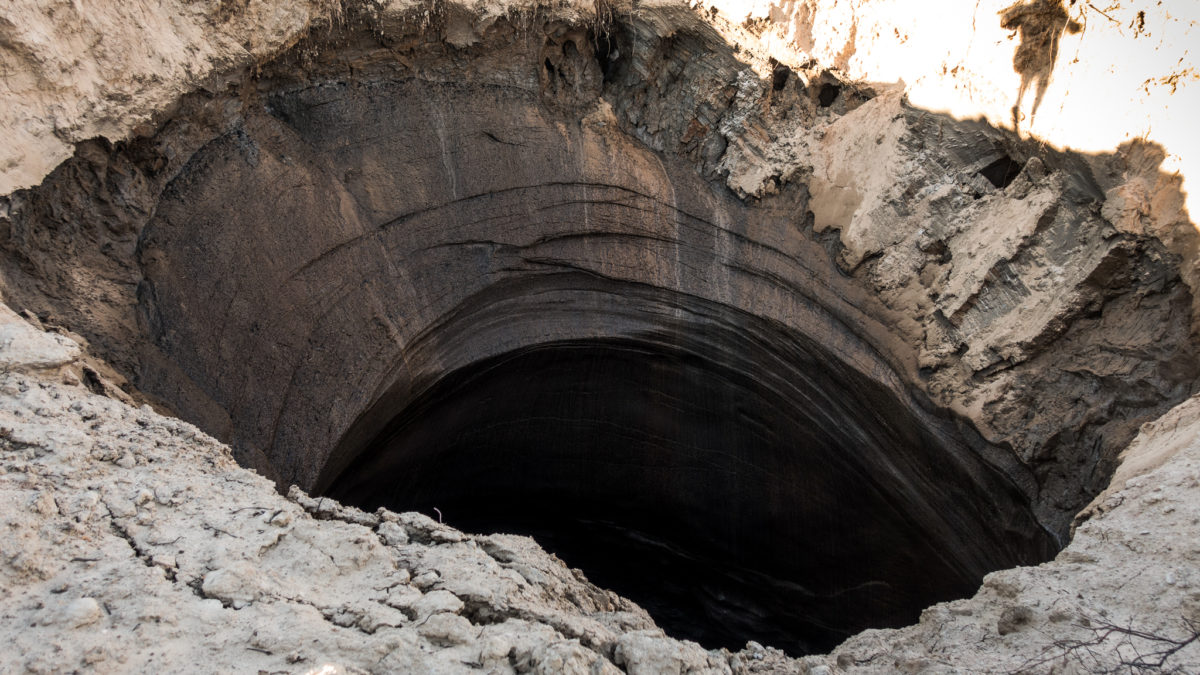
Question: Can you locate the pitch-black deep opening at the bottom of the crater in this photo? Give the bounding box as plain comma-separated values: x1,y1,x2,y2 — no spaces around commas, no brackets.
324,329,1054,655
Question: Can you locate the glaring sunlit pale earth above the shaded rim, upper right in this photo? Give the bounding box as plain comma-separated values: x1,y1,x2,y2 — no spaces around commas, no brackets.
706,0,1200,221
